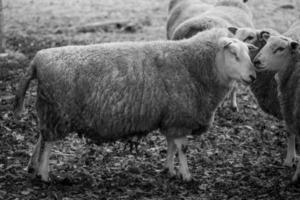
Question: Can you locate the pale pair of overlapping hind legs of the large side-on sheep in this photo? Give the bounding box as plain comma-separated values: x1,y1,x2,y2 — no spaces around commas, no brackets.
28,131,52,182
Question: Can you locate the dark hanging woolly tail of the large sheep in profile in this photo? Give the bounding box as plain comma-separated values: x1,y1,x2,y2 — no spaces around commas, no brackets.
13,61,36,117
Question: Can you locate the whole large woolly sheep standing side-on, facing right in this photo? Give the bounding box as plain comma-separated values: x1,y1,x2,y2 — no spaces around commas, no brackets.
14,29,255,181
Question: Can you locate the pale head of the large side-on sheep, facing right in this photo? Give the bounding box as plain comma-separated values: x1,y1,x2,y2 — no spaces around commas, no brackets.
217,37,256,84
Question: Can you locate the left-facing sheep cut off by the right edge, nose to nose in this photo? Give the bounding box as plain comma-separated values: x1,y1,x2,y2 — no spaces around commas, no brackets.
254,34,300,182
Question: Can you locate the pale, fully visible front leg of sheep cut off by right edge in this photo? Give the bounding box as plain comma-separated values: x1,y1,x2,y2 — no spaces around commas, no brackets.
283,131,297,167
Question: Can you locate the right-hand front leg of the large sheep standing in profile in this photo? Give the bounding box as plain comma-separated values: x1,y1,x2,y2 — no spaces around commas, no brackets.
174,137,192,181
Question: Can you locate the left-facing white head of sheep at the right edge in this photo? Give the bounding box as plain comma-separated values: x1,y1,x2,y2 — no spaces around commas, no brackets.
253,36,299,71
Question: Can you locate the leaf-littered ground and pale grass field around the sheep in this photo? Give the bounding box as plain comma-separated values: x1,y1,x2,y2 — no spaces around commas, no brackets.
0,0,300,200
